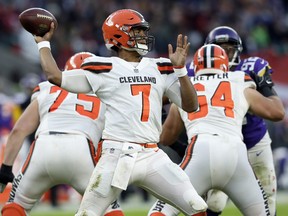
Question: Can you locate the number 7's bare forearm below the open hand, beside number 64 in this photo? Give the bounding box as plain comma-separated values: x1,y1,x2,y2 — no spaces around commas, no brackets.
179,76,198,112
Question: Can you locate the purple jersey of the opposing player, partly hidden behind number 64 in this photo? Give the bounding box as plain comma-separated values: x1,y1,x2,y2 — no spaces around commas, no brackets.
235,57,273,149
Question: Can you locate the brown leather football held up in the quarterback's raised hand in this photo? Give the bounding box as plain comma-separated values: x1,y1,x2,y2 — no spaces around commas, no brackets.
19,8,58,37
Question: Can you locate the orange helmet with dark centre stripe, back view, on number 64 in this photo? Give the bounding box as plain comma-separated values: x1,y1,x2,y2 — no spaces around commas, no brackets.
193,44,229,75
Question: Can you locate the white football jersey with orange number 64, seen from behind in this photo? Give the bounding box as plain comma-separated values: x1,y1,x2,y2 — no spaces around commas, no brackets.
179,71,256,140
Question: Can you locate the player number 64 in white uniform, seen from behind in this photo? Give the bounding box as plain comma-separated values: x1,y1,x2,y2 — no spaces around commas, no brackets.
149,44,285,216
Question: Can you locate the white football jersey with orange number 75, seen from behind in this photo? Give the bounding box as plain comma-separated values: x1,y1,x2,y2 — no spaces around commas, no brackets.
32,81,105,144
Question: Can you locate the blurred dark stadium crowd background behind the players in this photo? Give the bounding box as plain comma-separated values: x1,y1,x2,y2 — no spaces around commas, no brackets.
0,0,288,209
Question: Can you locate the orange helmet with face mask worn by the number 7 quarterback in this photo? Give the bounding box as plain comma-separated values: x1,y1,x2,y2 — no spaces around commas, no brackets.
102,9,154,55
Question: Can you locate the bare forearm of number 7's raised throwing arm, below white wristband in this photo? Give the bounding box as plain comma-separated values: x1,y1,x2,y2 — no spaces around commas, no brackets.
39,47,62,86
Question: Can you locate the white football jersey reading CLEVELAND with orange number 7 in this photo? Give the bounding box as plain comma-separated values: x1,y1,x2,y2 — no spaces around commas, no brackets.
62,56,181,143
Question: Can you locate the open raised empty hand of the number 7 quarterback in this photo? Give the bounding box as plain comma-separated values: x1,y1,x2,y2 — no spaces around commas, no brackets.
168,34,190,67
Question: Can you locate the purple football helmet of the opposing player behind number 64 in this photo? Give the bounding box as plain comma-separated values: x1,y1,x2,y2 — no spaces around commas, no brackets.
205,26,243,67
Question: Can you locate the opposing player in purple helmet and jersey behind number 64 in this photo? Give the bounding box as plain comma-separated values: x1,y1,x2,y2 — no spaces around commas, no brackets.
188,26,277,216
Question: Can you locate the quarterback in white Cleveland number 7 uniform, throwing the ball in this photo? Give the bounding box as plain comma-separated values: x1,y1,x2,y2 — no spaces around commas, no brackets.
35,9,207,216
